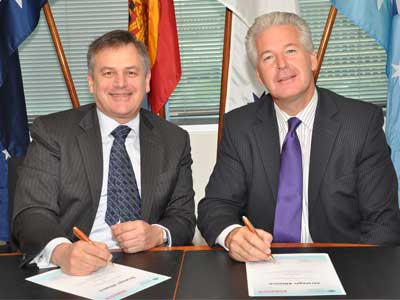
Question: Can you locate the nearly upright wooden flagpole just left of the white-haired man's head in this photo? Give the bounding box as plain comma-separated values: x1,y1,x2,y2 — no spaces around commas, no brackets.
218,8,232,144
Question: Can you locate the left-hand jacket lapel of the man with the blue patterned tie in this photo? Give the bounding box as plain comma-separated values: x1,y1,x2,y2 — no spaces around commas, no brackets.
77,106,103,221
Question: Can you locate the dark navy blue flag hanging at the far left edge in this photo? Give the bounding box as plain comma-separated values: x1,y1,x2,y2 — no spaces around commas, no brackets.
0,0,46,241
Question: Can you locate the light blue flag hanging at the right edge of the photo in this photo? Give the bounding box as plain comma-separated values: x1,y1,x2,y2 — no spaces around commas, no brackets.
331,0,400,204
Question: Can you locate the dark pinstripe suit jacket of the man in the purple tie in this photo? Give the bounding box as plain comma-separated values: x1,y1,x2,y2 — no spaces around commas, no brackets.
198,89,400,245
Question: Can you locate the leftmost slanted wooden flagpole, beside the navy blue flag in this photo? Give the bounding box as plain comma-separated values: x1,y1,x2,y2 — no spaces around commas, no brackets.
43,2,80,108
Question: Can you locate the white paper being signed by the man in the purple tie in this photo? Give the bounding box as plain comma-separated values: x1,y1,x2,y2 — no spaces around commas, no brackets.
246,253,346,297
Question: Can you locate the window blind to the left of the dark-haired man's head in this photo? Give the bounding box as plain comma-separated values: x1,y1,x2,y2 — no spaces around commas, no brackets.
20,0,128,121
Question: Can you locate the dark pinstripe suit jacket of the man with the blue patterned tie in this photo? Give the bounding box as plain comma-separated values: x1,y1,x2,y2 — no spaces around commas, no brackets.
12,104,195,260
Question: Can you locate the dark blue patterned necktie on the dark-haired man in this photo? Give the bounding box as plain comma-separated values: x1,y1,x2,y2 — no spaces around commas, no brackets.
105,125,142,226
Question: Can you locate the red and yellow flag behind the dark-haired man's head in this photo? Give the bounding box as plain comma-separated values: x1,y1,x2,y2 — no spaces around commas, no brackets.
128,0,182,113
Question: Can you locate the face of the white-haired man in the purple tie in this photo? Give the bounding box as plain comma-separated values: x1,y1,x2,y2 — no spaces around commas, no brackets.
256,25,317,109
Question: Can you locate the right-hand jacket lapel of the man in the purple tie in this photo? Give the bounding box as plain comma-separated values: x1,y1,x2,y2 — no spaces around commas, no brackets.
308,90,340,214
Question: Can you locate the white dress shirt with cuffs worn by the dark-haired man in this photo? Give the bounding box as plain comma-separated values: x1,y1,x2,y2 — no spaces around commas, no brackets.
32,109,172,268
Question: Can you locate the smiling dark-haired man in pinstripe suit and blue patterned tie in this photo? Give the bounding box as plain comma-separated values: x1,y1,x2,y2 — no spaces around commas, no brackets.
12,30,195,275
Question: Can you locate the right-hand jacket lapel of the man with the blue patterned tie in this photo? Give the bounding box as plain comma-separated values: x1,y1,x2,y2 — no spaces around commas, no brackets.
139,111,164,220
